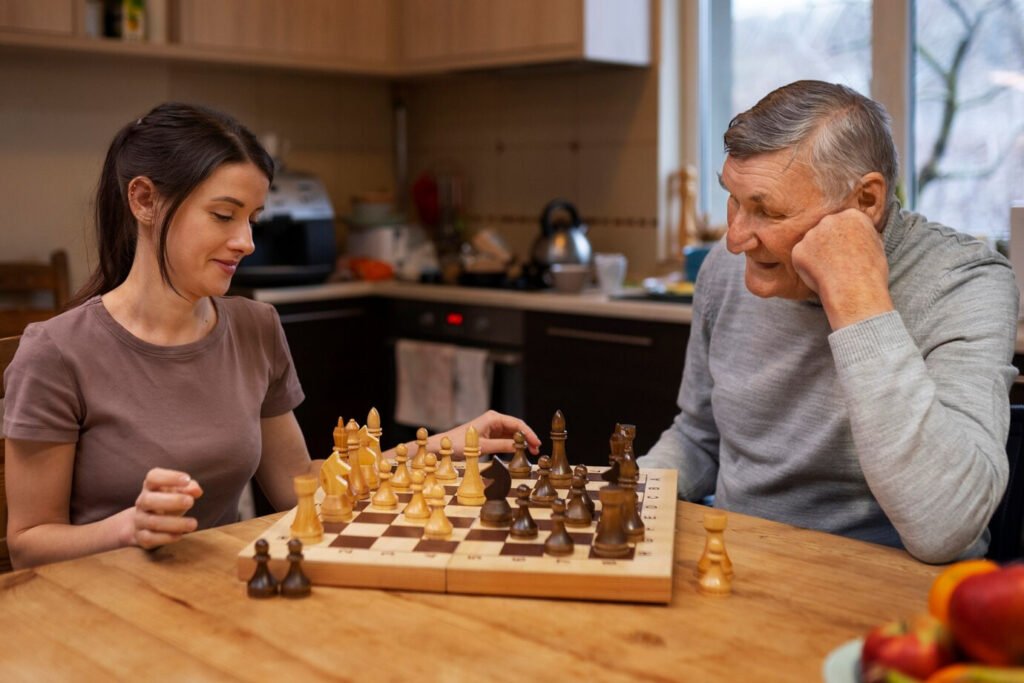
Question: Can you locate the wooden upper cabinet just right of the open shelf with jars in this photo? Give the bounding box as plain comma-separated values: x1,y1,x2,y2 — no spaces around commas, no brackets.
178,0,395,74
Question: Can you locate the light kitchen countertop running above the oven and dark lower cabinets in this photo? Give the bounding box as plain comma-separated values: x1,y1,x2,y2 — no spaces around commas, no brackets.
246,281,1024,353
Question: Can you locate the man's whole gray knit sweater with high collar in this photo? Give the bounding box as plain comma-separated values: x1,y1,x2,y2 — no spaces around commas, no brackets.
639,207,1018,562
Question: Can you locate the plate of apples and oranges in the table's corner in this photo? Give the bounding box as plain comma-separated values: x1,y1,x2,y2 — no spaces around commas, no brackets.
823,560,1024,683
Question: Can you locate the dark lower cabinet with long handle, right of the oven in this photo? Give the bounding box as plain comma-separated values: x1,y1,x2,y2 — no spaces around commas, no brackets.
524,311,689,465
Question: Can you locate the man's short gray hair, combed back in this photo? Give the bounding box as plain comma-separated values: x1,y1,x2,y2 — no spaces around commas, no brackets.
725,81,899,202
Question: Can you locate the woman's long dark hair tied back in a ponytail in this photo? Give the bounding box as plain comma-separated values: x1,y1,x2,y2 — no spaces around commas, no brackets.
68,102,273,308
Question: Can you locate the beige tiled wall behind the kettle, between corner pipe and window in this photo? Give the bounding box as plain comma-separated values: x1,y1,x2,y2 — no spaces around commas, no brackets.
403,67,657,276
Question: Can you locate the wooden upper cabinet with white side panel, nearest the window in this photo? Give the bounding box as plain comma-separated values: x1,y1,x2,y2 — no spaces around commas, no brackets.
398,0,651,74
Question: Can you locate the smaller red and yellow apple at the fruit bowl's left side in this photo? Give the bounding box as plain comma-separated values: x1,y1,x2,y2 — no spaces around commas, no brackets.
860,614,953,683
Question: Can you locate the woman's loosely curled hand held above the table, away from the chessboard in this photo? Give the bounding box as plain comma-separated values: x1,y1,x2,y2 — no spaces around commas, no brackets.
125,467,203,549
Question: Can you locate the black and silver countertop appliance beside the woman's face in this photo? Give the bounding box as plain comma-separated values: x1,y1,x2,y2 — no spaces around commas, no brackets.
232,170,337,287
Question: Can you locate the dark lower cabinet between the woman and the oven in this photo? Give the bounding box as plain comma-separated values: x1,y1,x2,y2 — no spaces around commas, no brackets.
276,299,392,458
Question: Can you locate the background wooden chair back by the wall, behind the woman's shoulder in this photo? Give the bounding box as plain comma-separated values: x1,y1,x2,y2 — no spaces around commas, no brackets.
0,249,71,337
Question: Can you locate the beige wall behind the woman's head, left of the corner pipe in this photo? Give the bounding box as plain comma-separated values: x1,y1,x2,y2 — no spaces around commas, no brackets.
0,50,393,288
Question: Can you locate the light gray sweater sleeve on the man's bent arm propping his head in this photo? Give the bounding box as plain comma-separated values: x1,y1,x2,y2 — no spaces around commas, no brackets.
828,262,1018,562
